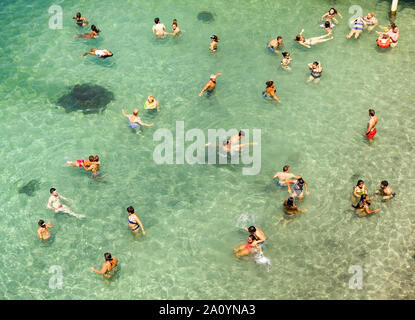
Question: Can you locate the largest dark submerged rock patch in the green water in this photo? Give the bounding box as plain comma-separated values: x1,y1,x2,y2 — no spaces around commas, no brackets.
57,83,114,113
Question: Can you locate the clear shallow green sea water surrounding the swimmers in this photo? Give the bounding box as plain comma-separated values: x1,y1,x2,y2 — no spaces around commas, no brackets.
0,0,415,299
